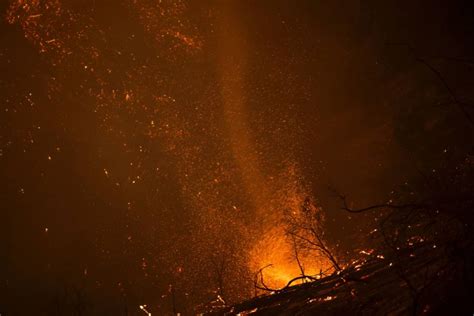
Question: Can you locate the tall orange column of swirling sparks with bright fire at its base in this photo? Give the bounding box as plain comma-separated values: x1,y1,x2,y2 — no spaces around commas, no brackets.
215,6,334,288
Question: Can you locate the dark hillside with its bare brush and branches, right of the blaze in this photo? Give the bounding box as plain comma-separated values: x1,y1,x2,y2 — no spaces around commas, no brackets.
209,158,474,315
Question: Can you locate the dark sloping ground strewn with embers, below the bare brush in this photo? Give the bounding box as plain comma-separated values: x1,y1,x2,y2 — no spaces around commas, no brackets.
206,245,473,315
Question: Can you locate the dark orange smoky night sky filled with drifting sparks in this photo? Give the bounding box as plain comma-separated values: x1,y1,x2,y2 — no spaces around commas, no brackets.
0,0,474,315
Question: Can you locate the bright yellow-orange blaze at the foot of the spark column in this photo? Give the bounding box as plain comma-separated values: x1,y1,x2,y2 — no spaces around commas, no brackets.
249,225,331,289
